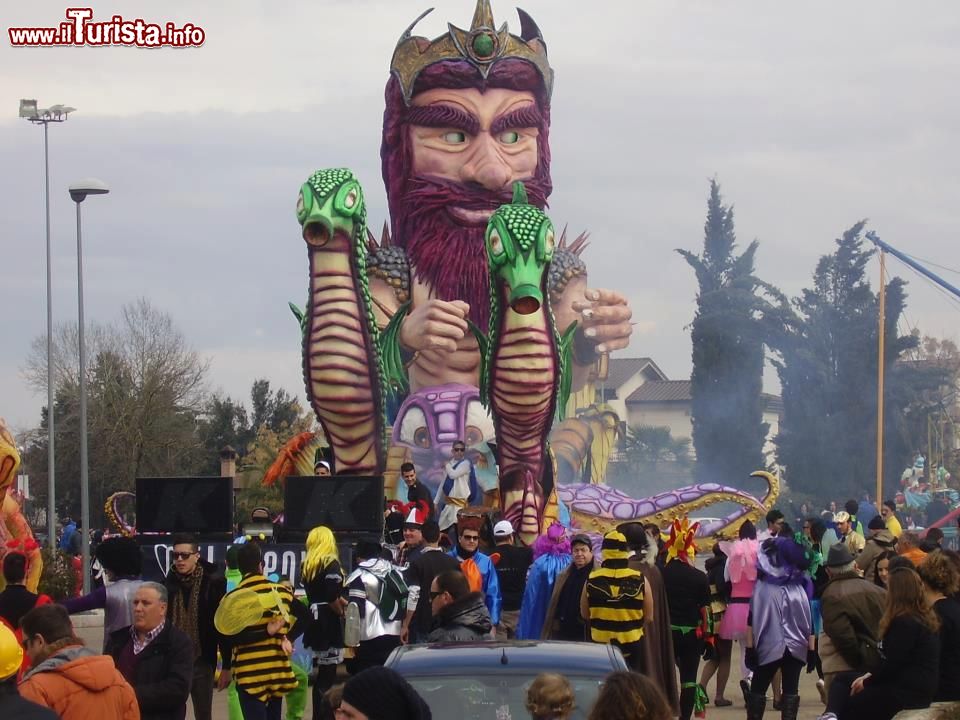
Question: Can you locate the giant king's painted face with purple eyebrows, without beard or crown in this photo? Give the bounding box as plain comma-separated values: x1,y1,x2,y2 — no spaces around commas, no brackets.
409,88,540,200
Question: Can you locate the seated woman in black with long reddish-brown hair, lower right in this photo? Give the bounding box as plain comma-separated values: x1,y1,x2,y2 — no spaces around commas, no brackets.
820,568,940,720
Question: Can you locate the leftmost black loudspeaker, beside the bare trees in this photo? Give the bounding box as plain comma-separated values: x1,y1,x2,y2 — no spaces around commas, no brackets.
137,477,233,535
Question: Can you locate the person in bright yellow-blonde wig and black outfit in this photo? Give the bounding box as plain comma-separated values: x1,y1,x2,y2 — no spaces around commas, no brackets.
300,525,346,718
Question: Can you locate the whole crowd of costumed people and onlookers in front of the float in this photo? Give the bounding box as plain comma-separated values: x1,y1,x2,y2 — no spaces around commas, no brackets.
0,452,960,720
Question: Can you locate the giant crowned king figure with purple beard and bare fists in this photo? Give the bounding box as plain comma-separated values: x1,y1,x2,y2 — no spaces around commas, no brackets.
369,0,631,466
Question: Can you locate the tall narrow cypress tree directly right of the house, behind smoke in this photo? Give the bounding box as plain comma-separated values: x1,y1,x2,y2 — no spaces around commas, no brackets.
677,180,786,484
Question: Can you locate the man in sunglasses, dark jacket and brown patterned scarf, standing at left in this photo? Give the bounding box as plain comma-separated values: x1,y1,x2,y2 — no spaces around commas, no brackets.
166,533,231,720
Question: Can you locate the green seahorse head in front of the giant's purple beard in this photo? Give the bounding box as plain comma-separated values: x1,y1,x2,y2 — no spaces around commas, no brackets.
486,182,555,315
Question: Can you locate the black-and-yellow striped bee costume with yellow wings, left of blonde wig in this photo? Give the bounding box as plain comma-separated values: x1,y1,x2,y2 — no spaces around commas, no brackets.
233,575,297,702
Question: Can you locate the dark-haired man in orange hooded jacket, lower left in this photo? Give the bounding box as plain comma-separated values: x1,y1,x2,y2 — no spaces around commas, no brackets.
19,605,140,720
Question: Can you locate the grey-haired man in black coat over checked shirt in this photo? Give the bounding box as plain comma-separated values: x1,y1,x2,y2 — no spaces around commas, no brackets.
104,582,193,720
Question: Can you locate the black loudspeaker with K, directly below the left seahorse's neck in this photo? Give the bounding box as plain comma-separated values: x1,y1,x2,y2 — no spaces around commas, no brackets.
283,475,383,537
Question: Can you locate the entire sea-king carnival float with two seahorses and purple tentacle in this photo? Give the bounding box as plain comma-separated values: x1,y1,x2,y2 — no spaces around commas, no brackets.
264,0,779,544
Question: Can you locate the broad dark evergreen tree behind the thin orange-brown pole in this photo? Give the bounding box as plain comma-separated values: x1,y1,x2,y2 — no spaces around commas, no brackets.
774,221,926,499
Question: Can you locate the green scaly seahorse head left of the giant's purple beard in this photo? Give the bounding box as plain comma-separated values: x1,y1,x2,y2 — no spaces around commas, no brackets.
297,168,366,247
